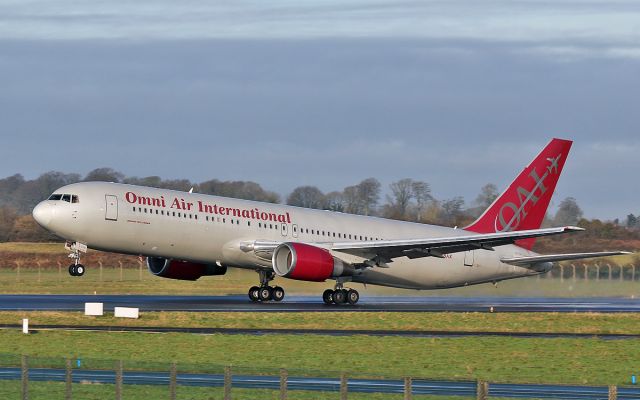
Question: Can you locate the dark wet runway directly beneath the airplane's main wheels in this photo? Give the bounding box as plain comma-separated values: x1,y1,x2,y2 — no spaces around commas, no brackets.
0,295,640,313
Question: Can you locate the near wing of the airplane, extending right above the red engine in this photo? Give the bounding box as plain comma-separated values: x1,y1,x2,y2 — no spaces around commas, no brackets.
329,226,584,264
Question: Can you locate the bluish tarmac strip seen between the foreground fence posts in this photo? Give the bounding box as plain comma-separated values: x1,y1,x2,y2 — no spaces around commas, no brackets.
0,368,640,400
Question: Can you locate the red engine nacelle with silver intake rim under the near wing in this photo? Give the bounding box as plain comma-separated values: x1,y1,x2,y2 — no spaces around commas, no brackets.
271,243,354,282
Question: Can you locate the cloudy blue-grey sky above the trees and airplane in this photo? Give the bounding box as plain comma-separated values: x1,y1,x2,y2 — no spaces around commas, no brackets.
0,0,640,219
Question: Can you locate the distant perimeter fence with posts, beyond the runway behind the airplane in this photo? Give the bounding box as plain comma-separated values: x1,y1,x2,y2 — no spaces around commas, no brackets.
0,259,640,282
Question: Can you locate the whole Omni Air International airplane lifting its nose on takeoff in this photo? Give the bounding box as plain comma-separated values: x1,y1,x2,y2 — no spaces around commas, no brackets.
33,139,627,305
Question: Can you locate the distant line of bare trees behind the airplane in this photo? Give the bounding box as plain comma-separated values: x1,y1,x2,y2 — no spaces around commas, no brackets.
0,168,640,252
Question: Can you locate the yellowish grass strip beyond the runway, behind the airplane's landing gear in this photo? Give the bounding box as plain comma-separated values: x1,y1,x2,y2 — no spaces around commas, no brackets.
0,266,640,301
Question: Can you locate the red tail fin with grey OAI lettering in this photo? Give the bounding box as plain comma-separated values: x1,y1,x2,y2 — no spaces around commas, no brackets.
465,139,572,249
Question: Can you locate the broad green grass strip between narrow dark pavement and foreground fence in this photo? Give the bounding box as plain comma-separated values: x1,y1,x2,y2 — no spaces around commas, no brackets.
0,330,640,385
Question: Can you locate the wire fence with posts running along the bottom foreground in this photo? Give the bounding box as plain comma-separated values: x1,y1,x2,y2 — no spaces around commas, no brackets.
0,354,640,400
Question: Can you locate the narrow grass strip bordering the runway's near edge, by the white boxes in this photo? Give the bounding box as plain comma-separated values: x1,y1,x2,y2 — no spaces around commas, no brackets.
0,311,640,335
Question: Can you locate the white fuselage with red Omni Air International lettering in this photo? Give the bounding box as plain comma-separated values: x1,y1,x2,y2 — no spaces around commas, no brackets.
34,182,546,289
